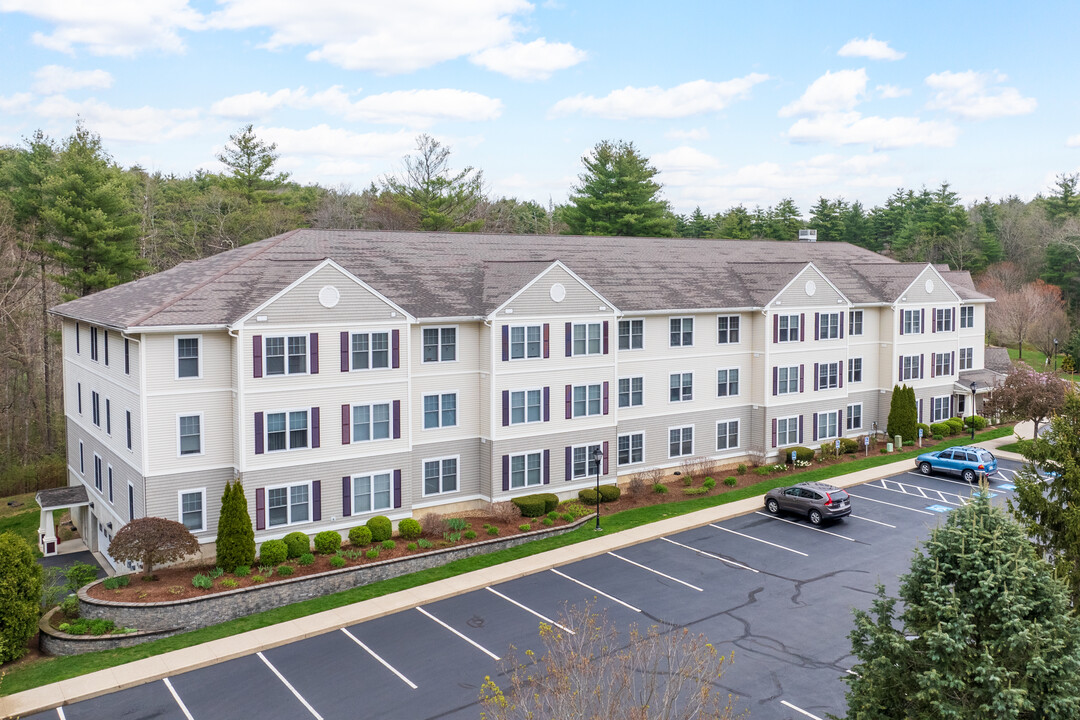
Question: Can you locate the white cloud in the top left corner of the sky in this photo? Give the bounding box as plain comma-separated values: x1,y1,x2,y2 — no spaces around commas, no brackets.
0,0,203,57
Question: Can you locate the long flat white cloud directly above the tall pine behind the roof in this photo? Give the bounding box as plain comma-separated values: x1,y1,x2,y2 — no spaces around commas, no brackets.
551,72,769,120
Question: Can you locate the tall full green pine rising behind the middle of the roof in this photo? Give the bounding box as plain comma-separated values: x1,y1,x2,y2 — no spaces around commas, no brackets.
563,140,675,237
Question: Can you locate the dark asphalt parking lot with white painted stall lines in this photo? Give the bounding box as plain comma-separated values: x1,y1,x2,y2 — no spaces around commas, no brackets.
21,460,1020,720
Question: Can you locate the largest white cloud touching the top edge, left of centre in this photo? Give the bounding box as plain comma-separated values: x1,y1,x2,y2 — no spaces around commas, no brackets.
210,0,532,73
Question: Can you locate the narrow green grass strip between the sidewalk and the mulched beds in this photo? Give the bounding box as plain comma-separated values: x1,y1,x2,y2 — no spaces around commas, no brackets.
0,426,1013,695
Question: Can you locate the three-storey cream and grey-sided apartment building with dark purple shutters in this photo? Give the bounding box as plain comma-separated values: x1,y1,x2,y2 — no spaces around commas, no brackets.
53,230,993,565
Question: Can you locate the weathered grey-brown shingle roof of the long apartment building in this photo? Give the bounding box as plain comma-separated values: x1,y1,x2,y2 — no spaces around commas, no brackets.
53,229,984,327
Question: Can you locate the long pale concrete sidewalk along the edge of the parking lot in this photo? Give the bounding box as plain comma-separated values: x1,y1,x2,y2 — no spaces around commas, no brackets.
0,425,1030,718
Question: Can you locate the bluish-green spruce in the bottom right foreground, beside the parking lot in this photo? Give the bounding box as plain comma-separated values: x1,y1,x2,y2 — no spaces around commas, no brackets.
846,485,1080,720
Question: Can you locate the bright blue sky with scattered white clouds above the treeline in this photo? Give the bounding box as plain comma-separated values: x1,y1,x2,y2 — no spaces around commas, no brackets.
0,0,1080,213
